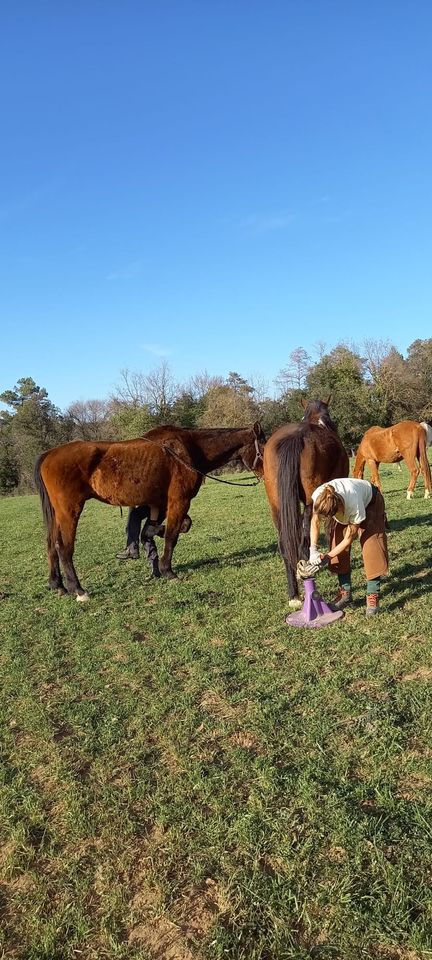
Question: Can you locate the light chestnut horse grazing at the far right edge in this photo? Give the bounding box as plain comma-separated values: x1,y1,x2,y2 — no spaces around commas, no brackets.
353,420,432,500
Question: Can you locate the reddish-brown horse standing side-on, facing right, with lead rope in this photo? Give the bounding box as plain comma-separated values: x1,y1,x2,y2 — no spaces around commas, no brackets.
35,423,265,600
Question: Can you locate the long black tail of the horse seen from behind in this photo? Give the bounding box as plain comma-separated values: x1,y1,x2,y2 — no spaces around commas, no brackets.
278,433,304,570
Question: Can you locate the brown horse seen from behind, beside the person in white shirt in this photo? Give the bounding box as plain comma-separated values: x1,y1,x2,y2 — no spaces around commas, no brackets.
264,397,349,606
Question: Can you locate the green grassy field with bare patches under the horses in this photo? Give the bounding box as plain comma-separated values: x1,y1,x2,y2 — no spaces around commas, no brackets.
0,467,432,960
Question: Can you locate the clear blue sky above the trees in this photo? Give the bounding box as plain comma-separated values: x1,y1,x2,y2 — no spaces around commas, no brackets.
0,0,432,407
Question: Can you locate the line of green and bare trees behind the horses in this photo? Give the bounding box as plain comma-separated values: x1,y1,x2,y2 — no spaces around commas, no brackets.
0,339,432,495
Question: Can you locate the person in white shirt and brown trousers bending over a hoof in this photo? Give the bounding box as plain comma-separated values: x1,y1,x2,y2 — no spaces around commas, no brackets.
309,477,388,617
